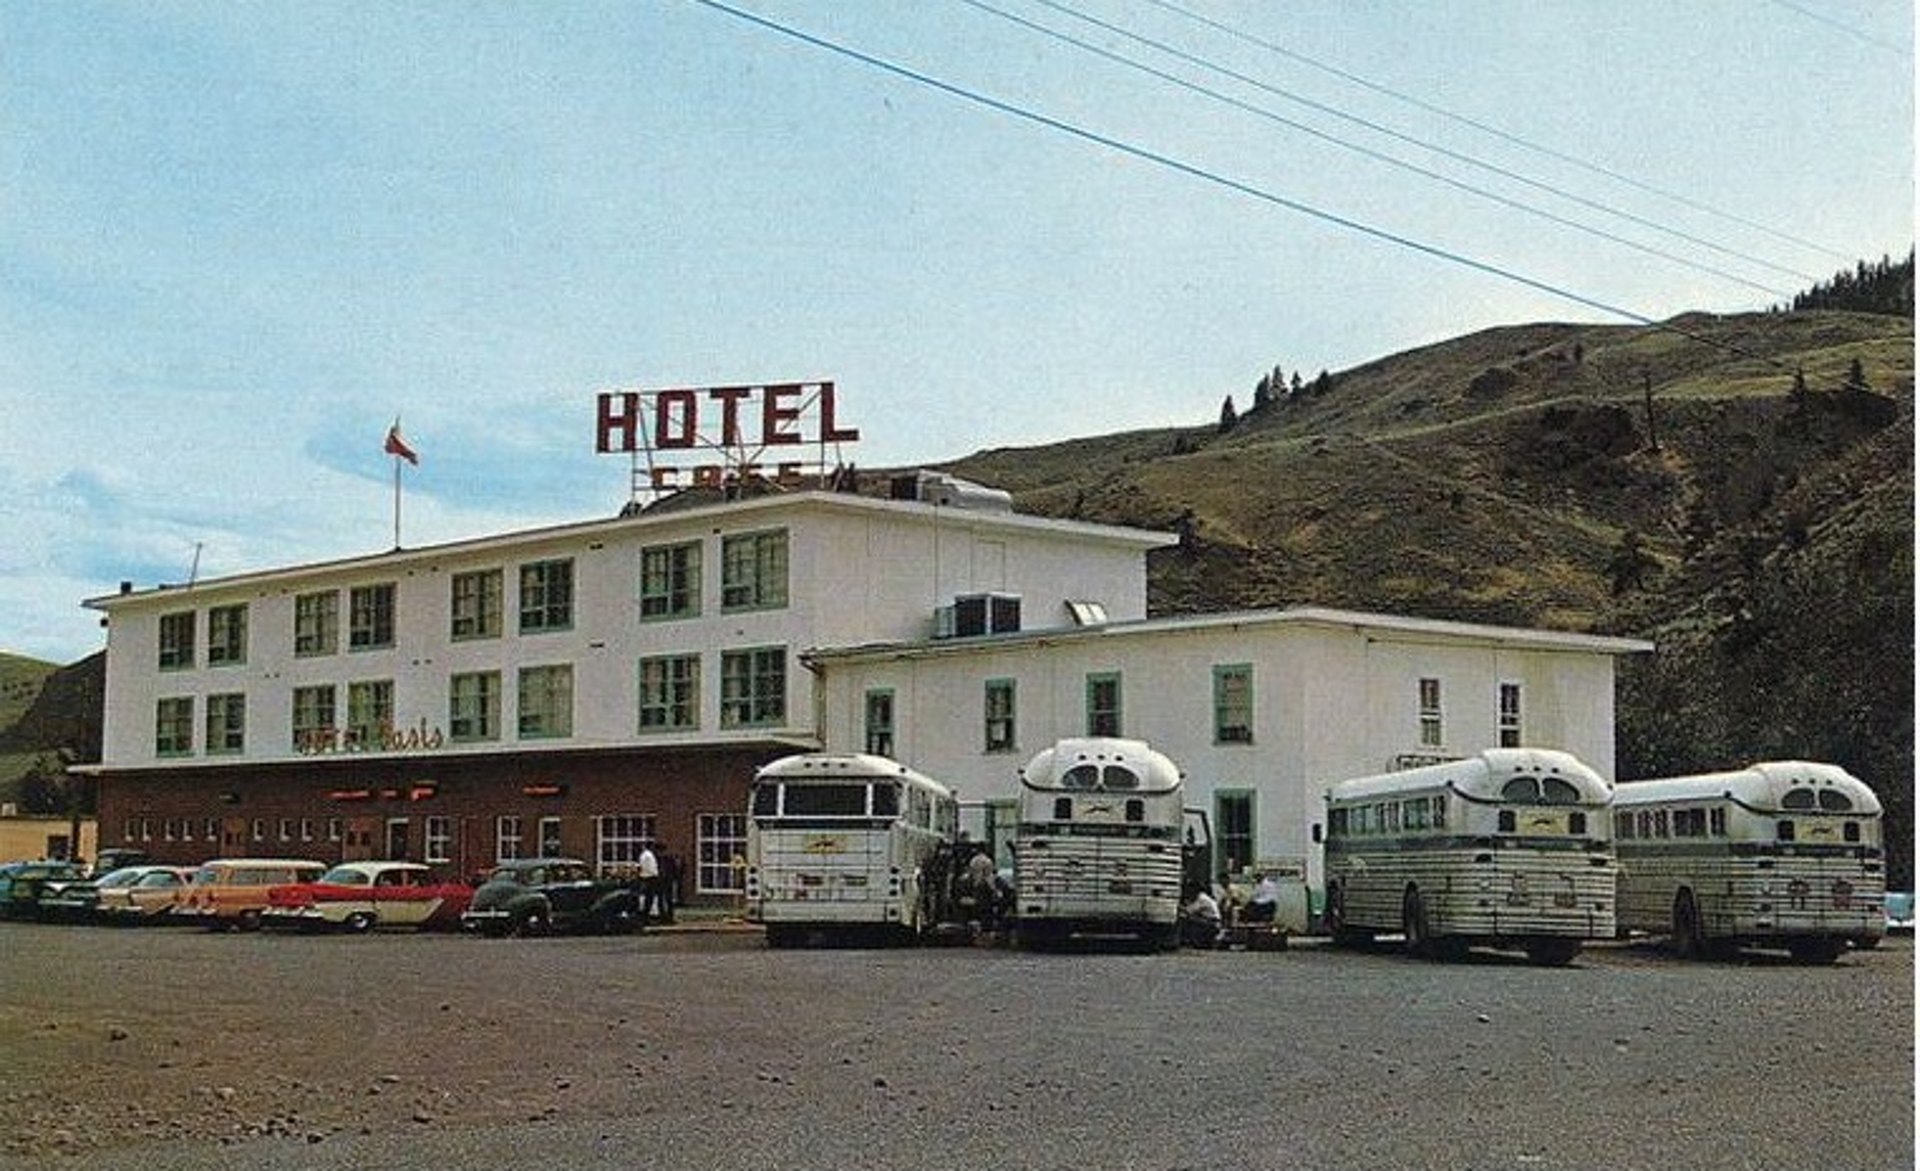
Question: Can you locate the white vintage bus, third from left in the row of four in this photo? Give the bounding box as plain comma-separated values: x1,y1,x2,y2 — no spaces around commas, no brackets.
1325,749,1615,964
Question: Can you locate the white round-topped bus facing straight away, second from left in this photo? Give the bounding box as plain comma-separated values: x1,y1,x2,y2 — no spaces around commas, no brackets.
1014,737,1187,948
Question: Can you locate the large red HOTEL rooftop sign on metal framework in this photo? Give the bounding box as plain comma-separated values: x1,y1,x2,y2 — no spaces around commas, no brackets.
595,382,860,491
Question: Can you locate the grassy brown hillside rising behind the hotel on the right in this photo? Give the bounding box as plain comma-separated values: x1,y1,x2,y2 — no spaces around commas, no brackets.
947,311,1914,885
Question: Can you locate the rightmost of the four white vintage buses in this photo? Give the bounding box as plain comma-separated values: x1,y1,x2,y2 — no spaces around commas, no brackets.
1613,760,1887,964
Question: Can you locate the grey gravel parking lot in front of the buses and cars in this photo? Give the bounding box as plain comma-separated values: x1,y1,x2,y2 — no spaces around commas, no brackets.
0,923,1914,1171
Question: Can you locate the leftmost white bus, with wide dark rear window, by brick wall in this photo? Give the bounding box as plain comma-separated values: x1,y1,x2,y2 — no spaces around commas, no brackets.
747,753,960,946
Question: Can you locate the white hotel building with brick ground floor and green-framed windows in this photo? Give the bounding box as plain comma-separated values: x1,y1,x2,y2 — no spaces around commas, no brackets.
86,478,1651,898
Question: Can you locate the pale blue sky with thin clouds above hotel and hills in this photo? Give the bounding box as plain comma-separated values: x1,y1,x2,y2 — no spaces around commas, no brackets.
0,0,1914,662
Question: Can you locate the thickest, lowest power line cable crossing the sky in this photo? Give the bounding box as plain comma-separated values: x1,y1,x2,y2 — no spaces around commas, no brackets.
687,0,1788,370
